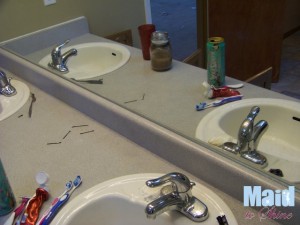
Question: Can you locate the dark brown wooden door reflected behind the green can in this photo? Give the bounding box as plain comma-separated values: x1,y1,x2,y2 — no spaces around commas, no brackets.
208,0,286,82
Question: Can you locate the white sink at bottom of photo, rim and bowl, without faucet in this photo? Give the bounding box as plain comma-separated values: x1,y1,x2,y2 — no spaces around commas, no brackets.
51,174,237,225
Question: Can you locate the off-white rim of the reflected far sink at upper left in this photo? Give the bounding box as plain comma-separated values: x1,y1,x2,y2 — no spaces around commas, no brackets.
38,42,131,80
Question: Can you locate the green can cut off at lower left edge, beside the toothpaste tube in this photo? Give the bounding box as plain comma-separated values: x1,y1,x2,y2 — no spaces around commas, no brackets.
0,159,16,216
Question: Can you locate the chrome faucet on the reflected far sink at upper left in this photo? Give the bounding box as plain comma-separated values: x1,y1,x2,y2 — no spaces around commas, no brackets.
48,40,77,73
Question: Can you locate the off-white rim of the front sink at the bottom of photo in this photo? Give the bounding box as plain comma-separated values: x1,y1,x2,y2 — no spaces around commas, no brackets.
51,173,237,225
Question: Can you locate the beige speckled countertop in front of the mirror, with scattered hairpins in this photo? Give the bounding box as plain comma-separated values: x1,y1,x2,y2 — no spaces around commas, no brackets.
0,73,284,225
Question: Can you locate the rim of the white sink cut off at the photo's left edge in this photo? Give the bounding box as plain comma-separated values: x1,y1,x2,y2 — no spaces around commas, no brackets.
0,79,30,121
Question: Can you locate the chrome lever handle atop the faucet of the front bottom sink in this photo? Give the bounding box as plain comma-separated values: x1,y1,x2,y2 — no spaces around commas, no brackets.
146,172,195,193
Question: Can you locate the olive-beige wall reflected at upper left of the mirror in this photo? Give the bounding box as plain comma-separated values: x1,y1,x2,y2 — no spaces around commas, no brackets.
0,0,146,46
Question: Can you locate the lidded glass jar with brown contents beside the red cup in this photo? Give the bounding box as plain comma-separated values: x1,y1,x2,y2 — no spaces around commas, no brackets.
150,31,172,71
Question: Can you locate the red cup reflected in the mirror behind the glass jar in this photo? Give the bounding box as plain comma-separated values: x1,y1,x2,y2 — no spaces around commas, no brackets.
138,24,155,60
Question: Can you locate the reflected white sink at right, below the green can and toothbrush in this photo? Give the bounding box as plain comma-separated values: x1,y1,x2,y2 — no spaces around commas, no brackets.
196,98,300,182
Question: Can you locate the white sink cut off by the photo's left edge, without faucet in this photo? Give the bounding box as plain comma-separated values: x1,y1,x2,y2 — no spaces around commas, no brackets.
0,79,30,121
